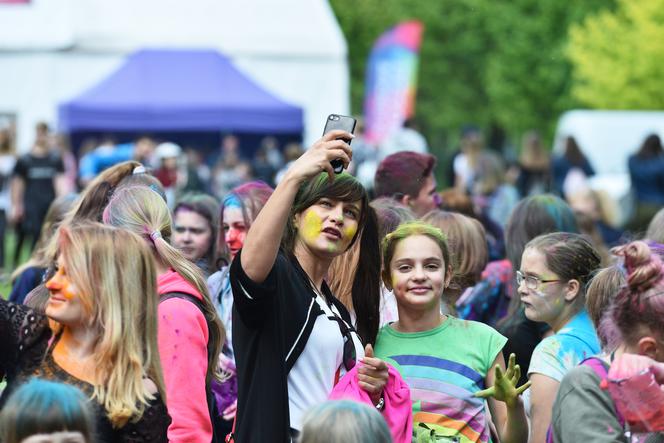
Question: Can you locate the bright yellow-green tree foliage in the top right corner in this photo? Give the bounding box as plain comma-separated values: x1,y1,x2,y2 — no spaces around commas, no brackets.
569,0,664,109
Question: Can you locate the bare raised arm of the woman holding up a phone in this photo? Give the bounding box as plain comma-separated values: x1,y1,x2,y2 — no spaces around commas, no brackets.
240,131,353,283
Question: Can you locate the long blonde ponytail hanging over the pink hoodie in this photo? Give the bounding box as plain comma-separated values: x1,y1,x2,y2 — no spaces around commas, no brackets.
103,186,226,383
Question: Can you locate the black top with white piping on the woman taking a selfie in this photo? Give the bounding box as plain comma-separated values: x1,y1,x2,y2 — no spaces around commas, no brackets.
230,251,350,443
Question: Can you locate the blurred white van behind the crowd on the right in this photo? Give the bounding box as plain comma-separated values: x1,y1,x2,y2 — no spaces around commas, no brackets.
553,110,664,227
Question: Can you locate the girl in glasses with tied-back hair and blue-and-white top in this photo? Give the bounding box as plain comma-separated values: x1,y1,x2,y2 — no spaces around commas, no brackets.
517,232,601,442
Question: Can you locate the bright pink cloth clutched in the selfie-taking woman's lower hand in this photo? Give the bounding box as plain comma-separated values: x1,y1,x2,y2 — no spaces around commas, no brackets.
330,364,413,443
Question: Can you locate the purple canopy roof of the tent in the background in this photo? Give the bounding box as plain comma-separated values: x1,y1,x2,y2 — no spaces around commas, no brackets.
58,50,302,134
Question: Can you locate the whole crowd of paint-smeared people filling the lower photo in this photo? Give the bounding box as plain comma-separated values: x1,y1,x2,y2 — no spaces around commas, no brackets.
0,119,664,443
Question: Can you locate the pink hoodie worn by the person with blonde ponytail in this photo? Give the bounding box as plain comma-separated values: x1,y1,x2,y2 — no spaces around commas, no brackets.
157,269,212,443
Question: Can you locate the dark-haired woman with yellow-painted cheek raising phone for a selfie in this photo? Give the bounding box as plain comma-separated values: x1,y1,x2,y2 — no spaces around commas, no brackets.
230,131,387,442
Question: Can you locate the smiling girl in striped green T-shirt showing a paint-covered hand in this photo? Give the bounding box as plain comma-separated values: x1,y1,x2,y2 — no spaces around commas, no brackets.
376,222,528,442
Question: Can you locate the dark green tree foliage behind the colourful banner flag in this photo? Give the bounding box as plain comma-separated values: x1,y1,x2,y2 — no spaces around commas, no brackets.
331,0,613,155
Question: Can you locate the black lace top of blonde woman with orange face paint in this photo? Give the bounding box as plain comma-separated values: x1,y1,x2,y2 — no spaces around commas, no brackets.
0,298,171,443
